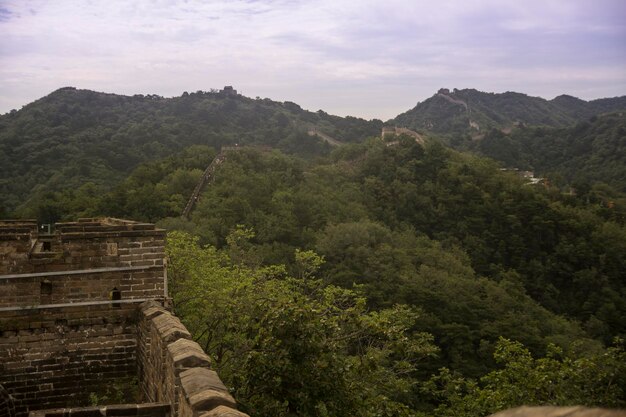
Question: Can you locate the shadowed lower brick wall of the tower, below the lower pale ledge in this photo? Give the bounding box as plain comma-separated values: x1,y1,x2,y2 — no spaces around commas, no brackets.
0,304,137,417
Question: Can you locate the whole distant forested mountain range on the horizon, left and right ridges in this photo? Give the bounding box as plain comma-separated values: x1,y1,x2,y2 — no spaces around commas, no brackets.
0,87,626,214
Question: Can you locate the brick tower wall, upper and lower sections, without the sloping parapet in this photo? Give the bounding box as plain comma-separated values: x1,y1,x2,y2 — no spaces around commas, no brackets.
0,219,166,416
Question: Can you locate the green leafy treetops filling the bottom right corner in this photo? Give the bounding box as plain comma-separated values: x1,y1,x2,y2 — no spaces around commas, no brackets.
424,339,626,417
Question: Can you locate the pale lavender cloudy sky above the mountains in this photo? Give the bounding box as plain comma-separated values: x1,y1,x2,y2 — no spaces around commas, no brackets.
0,0,626,120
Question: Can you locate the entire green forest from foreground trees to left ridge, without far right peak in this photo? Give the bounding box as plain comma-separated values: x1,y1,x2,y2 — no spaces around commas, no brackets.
0,89,626,417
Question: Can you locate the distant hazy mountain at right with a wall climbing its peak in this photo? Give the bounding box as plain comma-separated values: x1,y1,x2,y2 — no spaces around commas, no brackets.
388,88,626,138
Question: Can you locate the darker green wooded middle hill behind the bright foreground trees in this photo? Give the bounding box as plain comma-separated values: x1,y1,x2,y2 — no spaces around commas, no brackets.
152,142,626,377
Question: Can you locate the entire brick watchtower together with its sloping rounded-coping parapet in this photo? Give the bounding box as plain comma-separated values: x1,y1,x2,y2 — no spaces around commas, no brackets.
0,218,245,417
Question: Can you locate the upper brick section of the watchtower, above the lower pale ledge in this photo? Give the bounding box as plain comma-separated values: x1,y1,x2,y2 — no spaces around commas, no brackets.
0,218,167,310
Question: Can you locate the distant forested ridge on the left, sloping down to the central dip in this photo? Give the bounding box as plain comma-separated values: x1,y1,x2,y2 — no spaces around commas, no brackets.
0,87,382,210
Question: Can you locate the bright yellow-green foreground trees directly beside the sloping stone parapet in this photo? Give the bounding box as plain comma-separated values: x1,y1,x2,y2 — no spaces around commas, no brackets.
167,228,436,417
